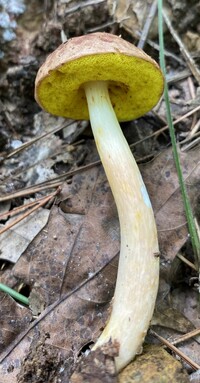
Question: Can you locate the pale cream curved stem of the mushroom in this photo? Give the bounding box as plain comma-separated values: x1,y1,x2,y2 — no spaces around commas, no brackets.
84,81,159,371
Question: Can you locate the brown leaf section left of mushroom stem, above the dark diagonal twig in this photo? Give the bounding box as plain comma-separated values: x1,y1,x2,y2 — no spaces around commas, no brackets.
10,167,119,304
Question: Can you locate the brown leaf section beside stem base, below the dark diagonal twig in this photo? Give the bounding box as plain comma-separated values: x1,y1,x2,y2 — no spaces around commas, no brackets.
0,265,117,383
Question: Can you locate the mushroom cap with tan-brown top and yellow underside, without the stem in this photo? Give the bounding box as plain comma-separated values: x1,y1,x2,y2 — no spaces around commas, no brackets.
35,32,164,121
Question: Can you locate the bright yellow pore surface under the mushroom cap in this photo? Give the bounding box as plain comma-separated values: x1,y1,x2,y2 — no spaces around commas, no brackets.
36,53,163,121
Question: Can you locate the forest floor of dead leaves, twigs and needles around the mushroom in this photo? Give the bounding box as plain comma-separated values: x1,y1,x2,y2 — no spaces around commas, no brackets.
0,0,200,383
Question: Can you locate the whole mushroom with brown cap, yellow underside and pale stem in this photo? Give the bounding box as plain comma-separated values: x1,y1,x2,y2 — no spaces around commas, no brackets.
35,33,163,371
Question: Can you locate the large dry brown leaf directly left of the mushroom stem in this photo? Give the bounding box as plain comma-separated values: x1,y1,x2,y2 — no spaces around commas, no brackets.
0,168,119,383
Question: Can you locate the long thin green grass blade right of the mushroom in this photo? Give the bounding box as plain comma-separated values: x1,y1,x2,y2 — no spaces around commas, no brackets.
158,0,200,269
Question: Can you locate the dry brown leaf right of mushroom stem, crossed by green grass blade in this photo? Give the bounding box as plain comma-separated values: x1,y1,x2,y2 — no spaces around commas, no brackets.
141,148,200,260
